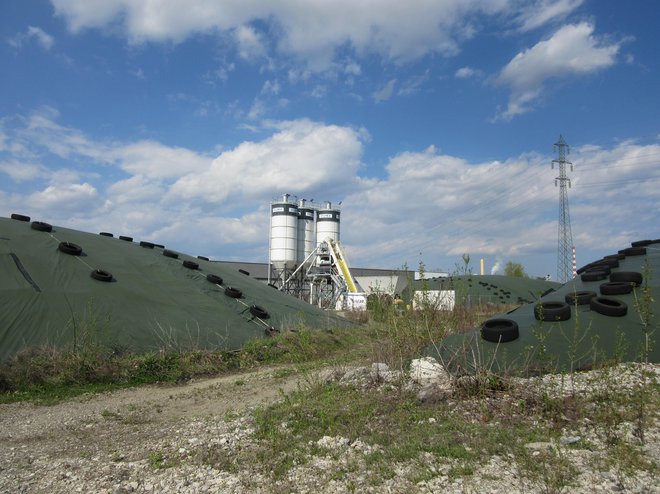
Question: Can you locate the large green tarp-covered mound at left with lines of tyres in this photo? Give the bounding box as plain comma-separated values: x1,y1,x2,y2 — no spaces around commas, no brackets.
0,214,348,361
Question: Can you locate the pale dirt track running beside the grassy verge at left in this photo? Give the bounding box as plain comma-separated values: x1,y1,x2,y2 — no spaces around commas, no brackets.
0,367,301,476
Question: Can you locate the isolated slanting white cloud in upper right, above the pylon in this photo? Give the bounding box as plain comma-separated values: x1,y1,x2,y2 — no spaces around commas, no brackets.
496,22,620,119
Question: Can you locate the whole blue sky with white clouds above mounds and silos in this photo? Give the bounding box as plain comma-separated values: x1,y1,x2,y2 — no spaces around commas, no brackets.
0,0,660,278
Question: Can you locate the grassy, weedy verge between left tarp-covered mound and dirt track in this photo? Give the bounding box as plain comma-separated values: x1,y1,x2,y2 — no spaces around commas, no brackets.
0,329,374,404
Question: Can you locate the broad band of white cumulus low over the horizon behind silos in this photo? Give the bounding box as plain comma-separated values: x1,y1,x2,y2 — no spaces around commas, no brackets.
0,111,660,275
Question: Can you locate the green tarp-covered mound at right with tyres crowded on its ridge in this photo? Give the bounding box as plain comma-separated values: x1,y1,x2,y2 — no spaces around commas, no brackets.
424,239,660,374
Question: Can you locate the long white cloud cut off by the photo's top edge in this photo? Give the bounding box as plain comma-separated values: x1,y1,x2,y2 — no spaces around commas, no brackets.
52,0,515,72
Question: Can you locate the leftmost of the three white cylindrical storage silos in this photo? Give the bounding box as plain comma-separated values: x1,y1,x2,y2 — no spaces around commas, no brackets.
270,194,298,270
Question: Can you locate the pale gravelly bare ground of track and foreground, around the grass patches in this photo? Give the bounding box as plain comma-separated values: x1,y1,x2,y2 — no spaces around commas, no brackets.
0,365,660,494
